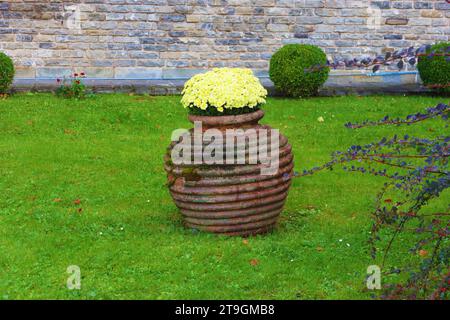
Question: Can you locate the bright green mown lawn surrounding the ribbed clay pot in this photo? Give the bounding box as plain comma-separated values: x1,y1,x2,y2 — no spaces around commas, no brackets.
0,94,442,299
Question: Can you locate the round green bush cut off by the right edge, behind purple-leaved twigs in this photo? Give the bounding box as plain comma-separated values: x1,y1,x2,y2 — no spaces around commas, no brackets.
417,42,450,92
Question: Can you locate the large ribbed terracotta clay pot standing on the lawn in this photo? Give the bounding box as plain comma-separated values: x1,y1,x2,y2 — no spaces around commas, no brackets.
165,110,294,236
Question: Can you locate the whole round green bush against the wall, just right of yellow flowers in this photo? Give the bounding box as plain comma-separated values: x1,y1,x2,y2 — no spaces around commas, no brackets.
269,44,330,97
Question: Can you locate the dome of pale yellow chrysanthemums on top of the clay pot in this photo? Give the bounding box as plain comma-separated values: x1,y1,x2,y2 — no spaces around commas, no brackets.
181,68,267,112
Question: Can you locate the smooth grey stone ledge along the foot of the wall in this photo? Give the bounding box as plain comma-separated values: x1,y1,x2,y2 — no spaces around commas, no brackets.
13,71,429,96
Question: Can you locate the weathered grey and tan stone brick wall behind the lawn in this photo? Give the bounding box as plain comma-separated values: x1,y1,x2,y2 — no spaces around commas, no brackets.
0,0,450,79
